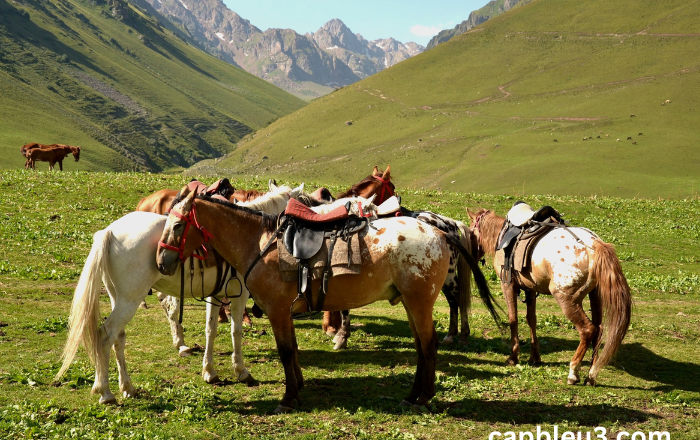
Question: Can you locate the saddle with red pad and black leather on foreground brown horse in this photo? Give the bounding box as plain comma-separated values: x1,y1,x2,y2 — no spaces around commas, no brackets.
278,199,368,318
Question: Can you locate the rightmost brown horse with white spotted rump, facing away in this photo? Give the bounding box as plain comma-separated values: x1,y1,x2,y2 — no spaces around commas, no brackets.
467,209,632,385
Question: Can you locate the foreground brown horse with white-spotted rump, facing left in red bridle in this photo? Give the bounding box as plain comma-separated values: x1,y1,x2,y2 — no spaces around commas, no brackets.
156,187,494,413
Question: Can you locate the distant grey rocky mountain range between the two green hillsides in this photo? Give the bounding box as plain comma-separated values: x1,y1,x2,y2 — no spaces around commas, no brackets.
143,0,425,100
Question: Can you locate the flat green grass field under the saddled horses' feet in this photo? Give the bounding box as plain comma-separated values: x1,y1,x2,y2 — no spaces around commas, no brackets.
0,171,700,440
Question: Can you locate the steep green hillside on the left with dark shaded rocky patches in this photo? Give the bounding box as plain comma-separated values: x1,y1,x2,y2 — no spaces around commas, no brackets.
0,0,304,171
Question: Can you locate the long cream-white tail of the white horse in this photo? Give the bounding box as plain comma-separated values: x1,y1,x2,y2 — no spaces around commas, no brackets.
56,229,112,380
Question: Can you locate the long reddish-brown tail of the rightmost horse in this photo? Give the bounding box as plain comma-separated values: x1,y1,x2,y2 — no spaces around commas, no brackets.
589,240,632,381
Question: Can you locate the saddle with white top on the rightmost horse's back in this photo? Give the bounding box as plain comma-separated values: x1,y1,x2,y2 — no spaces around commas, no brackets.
496,201,566,283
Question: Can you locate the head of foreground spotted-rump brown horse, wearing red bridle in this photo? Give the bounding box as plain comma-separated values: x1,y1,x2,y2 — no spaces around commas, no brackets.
156,186,208,275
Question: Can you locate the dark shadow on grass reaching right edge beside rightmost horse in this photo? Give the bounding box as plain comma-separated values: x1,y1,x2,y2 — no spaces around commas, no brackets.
616,342,700,392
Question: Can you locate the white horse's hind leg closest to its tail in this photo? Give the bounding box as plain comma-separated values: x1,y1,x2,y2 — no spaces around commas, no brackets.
92,300,145,404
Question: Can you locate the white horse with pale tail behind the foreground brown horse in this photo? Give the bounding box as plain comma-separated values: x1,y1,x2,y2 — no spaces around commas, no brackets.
56,184,303,403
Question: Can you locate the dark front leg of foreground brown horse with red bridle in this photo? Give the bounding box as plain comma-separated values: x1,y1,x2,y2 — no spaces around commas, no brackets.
266,307,299,414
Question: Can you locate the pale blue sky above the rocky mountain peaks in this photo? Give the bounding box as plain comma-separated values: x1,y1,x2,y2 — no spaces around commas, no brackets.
223,0,488,45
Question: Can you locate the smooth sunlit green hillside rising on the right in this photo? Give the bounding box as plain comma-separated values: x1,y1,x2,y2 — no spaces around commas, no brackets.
215,0,700,197
